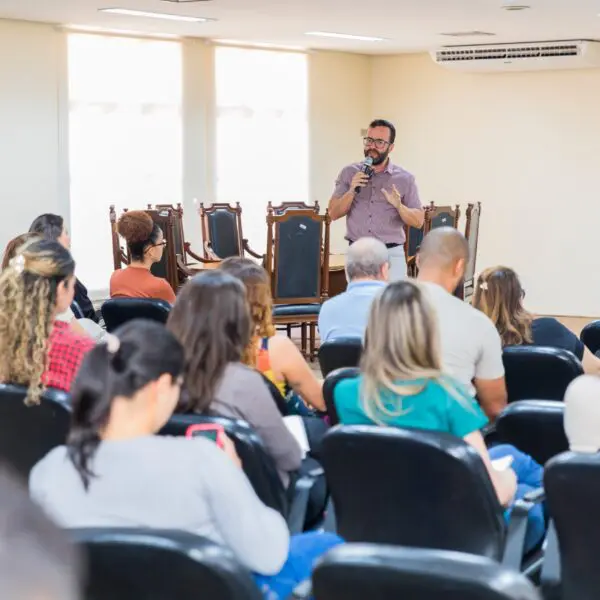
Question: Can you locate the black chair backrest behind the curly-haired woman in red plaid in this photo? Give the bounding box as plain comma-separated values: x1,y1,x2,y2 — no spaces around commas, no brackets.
0,384,71,478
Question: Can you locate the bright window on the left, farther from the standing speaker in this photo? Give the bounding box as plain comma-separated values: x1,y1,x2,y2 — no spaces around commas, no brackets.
68,34,183,291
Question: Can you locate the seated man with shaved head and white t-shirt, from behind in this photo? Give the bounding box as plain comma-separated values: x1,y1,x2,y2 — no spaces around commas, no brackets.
417,227,507,419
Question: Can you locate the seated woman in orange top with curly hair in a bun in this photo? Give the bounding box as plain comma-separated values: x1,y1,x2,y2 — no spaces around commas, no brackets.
110,210,175,304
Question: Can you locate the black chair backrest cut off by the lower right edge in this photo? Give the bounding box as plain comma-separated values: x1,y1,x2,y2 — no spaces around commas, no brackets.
544,452,600,600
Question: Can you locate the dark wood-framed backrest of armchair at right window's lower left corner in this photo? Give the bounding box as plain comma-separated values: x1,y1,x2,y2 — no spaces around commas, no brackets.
200,202,243,259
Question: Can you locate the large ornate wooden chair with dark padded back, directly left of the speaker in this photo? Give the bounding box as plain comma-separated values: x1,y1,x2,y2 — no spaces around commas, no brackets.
265,207,331,358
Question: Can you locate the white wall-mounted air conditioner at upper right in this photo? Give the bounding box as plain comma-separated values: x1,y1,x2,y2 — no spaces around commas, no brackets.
431,40,600,72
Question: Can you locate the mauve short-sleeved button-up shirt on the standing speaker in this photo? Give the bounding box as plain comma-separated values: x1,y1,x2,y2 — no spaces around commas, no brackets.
333,161,421,244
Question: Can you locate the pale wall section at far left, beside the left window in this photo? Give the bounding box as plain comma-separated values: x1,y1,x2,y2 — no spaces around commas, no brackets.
0,20,68,246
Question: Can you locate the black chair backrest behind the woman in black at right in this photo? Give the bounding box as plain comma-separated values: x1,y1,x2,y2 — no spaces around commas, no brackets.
502,346,583,402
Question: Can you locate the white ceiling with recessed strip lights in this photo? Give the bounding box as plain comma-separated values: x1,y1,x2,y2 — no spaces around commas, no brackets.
0,0,600,54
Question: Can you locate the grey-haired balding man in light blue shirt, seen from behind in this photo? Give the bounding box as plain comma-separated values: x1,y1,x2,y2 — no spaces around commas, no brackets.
319,237,390,342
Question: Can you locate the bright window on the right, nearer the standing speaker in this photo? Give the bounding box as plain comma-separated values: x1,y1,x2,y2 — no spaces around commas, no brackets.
215,47,309,252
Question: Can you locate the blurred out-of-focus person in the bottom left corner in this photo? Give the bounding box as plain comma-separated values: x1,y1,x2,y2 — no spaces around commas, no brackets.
0,468,80,600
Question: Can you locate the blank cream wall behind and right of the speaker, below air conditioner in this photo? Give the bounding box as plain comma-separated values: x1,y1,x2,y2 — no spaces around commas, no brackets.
372,55,600,316
